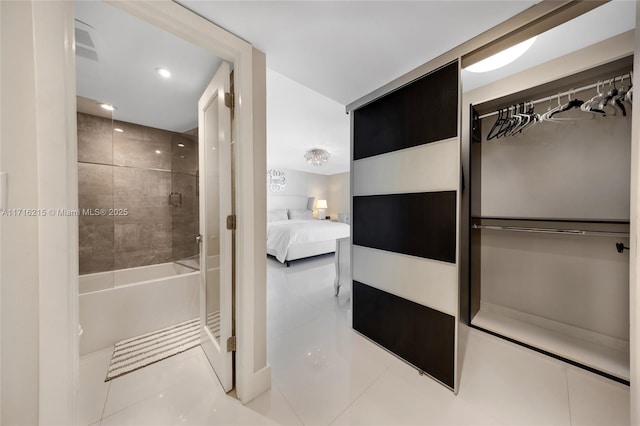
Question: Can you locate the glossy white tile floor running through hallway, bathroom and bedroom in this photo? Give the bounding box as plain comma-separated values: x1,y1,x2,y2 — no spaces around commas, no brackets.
80,256,629,426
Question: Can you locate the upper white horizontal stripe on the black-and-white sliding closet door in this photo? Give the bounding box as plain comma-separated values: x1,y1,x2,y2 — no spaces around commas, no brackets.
352,137,460,196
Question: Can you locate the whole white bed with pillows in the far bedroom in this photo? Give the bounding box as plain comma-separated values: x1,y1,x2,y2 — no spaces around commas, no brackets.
267,196,351,266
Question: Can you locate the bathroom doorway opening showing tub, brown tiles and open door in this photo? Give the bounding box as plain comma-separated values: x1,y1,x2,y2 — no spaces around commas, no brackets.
76,2,233,412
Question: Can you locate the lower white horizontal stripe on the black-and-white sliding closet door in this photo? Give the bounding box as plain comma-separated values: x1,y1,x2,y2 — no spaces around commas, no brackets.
352,246,458,316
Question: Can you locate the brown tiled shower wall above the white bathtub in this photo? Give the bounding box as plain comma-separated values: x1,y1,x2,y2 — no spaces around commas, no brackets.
78,113,198,274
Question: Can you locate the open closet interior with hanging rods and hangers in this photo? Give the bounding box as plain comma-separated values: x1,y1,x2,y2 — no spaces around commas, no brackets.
469,56,633,384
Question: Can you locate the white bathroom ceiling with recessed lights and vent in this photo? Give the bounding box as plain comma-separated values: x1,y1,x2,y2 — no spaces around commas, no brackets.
75,1,221,132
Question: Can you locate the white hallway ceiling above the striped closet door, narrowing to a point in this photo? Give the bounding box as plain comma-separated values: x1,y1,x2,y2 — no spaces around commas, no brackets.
179,0,538,105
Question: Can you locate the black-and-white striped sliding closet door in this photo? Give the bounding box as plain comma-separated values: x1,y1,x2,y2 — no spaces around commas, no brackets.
352,61,460,391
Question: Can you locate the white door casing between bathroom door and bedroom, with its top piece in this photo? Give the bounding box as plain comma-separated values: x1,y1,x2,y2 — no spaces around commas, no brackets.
99,0,271,403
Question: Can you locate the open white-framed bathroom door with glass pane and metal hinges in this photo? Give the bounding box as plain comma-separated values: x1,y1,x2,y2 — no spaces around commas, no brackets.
198,63,235,391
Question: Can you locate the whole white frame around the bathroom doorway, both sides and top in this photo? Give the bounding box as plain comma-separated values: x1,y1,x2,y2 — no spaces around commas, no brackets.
27,0,271,424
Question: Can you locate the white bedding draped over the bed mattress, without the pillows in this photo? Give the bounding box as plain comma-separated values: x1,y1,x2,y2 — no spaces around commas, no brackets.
267,219,350,262
